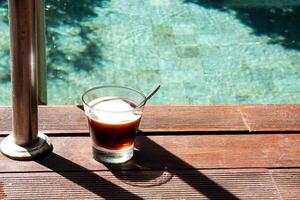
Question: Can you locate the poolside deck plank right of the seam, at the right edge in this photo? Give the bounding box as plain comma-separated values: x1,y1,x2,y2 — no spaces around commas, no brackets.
240,104,300,131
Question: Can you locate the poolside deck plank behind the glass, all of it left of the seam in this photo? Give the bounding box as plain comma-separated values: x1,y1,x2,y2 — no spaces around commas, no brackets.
0,105,248,134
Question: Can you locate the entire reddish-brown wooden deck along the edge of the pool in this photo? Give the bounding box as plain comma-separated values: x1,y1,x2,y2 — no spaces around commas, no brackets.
0,105,300,199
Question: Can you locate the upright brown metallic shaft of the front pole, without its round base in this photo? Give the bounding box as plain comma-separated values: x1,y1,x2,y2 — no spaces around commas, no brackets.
9,0,37,145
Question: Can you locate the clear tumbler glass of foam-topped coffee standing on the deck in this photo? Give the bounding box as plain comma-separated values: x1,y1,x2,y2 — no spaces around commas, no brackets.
82,85,146,163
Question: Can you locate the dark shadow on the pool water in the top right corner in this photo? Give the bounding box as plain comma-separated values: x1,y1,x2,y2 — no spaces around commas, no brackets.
185,0,300,50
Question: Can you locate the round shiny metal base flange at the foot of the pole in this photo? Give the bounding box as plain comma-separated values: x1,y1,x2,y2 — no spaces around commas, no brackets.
0,132,53,160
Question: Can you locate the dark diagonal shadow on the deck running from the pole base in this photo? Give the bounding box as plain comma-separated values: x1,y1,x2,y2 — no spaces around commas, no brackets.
35,153,142,199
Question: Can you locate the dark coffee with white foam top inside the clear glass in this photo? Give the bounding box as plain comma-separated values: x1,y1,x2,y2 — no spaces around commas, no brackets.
88,99,141,150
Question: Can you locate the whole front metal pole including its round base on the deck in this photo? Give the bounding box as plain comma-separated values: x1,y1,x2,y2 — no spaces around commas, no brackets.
0,0,52,160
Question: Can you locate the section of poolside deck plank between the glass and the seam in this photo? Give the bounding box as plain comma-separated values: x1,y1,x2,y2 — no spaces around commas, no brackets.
141,105,248,132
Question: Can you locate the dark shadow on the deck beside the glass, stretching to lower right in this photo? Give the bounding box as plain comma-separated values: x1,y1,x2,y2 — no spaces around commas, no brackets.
106,137,238,199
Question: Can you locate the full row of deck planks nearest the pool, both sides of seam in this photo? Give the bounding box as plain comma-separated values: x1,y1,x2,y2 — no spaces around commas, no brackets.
0,104,300,135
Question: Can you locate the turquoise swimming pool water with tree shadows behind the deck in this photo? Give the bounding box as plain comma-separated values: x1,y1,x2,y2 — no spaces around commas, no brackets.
0,0,300,105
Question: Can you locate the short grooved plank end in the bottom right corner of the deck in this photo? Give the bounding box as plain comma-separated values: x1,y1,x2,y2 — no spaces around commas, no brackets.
270,169,300,199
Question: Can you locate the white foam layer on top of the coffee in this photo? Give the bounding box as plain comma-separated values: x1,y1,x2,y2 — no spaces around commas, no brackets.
88,97,141,124
